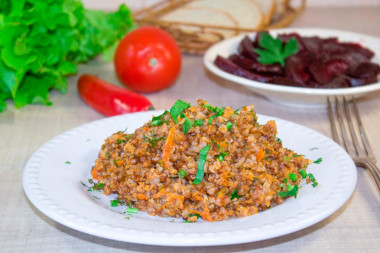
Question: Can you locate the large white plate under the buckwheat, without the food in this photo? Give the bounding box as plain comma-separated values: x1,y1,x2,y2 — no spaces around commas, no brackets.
23,111,356,246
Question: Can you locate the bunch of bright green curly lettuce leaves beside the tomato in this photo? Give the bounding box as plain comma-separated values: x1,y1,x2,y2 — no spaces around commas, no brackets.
0,0,133,112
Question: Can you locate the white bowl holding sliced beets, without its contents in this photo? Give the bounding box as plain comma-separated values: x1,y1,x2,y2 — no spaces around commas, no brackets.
203,28,380,107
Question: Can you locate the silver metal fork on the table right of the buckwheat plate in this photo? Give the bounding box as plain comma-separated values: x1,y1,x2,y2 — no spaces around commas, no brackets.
327,97,380,190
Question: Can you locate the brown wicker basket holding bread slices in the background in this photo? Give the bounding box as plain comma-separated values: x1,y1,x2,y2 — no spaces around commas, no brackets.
133,0,306,54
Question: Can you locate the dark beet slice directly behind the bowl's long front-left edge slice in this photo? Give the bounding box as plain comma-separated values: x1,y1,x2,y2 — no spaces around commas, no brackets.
228,54,283,75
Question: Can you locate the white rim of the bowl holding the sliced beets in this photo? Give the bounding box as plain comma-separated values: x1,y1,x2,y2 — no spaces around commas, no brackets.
203,28,380,96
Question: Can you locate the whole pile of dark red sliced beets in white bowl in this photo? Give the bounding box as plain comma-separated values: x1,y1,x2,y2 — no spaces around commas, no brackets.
215,31,380,88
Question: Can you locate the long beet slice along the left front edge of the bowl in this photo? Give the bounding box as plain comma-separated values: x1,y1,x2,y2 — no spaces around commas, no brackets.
214,55,272,83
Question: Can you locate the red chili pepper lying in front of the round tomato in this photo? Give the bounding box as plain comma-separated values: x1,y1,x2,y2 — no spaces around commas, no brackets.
78,74,153,116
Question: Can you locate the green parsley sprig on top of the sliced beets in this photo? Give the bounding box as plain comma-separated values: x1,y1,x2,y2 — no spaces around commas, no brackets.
254,32,299,67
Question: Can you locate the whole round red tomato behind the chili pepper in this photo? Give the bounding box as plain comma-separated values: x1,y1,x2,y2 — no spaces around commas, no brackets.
114,26,182,92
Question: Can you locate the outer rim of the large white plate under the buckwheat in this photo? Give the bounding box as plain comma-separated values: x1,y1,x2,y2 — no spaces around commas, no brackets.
22,110,357,246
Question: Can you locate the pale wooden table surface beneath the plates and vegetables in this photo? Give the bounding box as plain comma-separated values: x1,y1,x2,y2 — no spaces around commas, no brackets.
0,4,380,253
